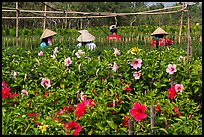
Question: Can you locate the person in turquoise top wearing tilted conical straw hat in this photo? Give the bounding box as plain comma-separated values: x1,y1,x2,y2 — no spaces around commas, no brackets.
40,29,57,49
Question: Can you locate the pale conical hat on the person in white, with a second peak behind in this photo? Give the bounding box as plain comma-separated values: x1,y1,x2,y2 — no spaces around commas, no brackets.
77,30,95,42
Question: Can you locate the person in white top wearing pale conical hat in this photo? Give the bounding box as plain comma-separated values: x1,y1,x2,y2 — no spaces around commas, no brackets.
77,30,96,50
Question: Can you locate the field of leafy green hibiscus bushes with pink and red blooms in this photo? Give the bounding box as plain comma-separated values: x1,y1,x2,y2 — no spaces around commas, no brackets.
2,38,202,135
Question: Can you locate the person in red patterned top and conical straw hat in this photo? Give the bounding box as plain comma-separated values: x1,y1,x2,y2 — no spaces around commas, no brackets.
151,27,173,48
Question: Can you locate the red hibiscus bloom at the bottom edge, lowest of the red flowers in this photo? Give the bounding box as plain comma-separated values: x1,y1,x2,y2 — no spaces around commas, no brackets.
63,121,81,135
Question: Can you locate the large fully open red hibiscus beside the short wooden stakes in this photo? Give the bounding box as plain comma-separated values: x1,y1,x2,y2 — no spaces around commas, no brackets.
130,102,147,121
